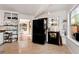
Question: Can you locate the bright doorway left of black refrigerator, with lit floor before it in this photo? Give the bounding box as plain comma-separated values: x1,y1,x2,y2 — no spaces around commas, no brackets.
18,19,32,48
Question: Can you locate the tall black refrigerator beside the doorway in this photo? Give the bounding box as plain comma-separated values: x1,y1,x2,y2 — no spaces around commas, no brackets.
32,18,47,44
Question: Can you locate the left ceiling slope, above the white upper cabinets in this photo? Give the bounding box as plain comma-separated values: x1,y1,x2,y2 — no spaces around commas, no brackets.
0,4,40,15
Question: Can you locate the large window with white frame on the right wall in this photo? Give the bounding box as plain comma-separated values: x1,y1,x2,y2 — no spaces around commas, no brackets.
70,5,79,41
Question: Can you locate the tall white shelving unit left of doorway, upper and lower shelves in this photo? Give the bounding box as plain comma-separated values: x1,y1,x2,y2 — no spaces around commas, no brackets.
4,12,18,42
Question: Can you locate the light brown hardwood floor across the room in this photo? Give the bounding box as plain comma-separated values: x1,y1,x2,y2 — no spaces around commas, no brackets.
0,39,70,54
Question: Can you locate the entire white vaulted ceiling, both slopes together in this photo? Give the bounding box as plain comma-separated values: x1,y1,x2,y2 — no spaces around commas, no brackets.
0,4,73,16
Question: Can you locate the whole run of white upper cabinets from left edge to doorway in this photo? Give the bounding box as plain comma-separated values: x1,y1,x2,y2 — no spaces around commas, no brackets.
0,10,18,26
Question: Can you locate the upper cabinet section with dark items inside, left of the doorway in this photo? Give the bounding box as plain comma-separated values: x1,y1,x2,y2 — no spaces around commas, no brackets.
4,12,18,25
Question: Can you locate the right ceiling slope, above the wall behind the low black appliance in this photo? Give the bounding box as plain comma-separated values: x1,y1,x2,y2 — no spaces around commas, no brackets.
48,4,74,12
